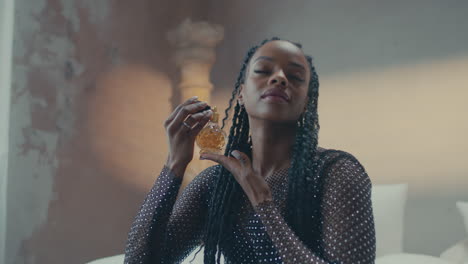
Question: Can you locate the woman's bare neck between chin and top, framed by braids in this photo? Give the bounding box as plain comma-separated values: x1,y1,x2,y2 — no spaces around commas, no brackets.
250,120,297,177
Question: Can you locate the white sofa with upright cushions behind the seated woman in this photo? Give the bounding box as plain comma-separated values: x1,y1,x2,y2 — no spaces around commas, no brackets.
88,184,468,264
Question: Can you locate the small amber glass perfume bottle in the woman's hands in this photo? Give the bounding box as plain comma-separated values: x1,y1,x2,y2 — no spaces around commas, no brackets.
195,106,226,155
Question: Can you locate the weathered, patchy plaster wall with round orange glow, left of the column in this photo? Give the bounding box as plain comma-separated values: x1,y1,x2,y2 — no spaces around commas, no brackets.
6,0,207,264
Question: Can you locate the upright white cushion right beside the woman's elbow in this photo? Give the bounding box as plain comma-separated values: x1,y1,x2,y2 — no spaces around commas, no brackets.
371,183,408,257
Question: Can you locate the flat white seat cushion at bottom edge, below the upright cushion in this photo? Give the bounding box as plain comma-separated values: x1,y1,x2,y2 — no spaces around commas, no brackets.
375,253,458,264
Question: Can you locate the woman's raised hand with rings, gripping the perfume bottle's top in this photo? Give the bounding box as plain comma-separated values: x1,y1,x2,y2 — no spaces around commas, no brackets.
164,97,213,178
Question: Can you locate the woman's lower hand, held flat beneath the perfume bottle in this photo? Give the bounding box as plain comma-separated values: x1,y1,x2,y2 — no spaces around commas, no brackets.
200,150,272,206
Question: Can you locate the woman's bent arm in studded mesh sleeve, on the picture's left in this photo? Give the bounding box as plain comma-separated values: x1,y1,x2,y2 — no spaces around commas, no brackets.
125,166,216,263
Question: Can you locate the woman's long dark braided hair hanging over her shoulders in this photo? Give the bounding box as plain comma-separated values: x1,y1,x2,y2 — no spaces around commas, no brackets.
200,37,320,264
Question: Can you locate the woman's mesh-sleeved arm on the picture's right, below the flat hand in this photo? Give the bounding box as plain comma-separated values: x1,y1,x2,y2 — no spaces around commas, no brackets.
254,155,376,264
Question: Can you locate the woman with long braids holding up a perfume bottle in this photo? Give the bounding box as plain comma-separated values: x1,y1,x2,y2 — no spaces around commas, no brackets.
125,38,376,264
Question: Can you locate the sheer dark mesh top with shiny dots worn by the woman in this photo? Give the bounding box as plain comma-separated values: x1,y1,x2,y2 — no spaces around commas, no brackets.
125,148,376,264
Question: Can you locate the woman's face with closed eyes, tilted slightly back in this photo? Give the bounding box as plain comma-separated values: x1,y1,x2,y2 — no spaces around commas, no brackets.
239,40,310,123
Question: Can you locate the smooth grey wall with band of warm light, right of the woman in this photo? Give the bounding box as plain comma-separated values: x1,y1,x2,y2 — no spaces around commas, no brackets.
210,0,468,256
